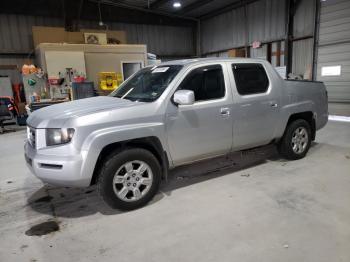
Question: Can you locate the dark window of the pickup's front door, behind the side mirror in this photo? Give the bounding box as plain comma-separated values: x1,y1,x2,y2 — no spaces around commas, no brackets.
179,65,225,101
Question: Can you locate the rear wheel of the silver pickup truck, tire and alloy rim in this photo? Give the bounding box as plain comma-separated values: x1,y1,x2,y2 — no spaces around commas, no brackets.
278,119,311,160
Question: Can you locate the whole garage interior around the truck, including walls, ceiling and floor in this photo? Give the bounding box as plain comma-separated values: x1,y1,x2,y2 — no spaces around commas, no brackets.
0,0,350,262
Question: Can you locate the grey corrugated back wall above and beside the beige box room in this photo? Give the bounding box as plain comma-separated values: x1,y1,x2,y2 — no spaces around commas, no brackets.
0,14,195,59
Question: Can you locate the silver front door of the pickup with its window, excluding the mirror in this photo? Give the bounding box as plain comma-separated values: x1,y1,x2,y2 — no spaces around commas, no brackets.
166,64,232,165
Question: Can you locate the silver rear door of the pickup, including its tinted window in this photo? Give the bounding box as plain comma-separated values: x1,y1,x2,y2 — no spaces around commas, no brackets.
230,63,281,150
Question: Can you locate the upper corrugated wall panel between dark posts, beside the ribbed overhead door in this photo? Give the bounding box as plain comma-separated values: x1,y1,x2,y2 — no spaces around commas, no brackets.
293,0,316,37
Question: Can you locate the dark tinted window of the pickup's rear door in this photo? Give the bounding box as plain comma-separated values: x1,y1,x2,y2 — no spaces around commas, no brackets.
232,64,269,95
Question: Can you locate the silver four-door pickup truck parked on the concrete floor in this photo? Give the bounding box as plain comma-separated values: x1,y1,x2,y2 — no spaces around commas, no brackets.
24,59,328,210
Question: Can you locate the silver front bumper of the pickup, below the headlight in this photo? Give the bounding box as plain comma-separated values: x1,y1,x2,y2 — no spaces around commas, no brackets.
24,142,91,187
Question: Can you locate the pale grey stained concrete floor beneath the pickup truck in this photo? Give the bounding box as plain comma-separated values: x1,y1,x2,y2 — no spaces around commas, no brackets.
0,121,350,262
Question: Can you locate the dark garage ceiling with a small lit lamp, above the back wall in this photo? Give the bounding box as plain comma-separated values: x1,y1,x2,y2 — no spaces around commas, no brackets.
0,0,249,24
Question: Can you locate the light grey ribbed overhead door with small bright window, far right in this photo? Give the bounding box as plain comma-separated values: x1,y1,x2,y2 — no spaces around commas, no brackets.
317,0,350,102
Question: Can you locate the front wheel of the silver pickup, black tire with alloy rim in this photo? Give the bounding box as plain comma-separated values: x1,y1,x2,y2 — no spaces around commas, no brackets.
97,148,161,210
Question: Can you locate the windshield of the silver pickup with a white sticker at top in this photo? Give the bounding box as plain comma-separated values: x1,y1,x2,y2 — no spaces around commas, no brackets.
110,65,182,102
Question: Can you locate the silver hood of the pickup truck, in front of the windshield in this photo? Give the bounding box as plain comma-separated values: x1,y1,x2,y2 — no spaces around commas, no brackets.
27,96,138,128
